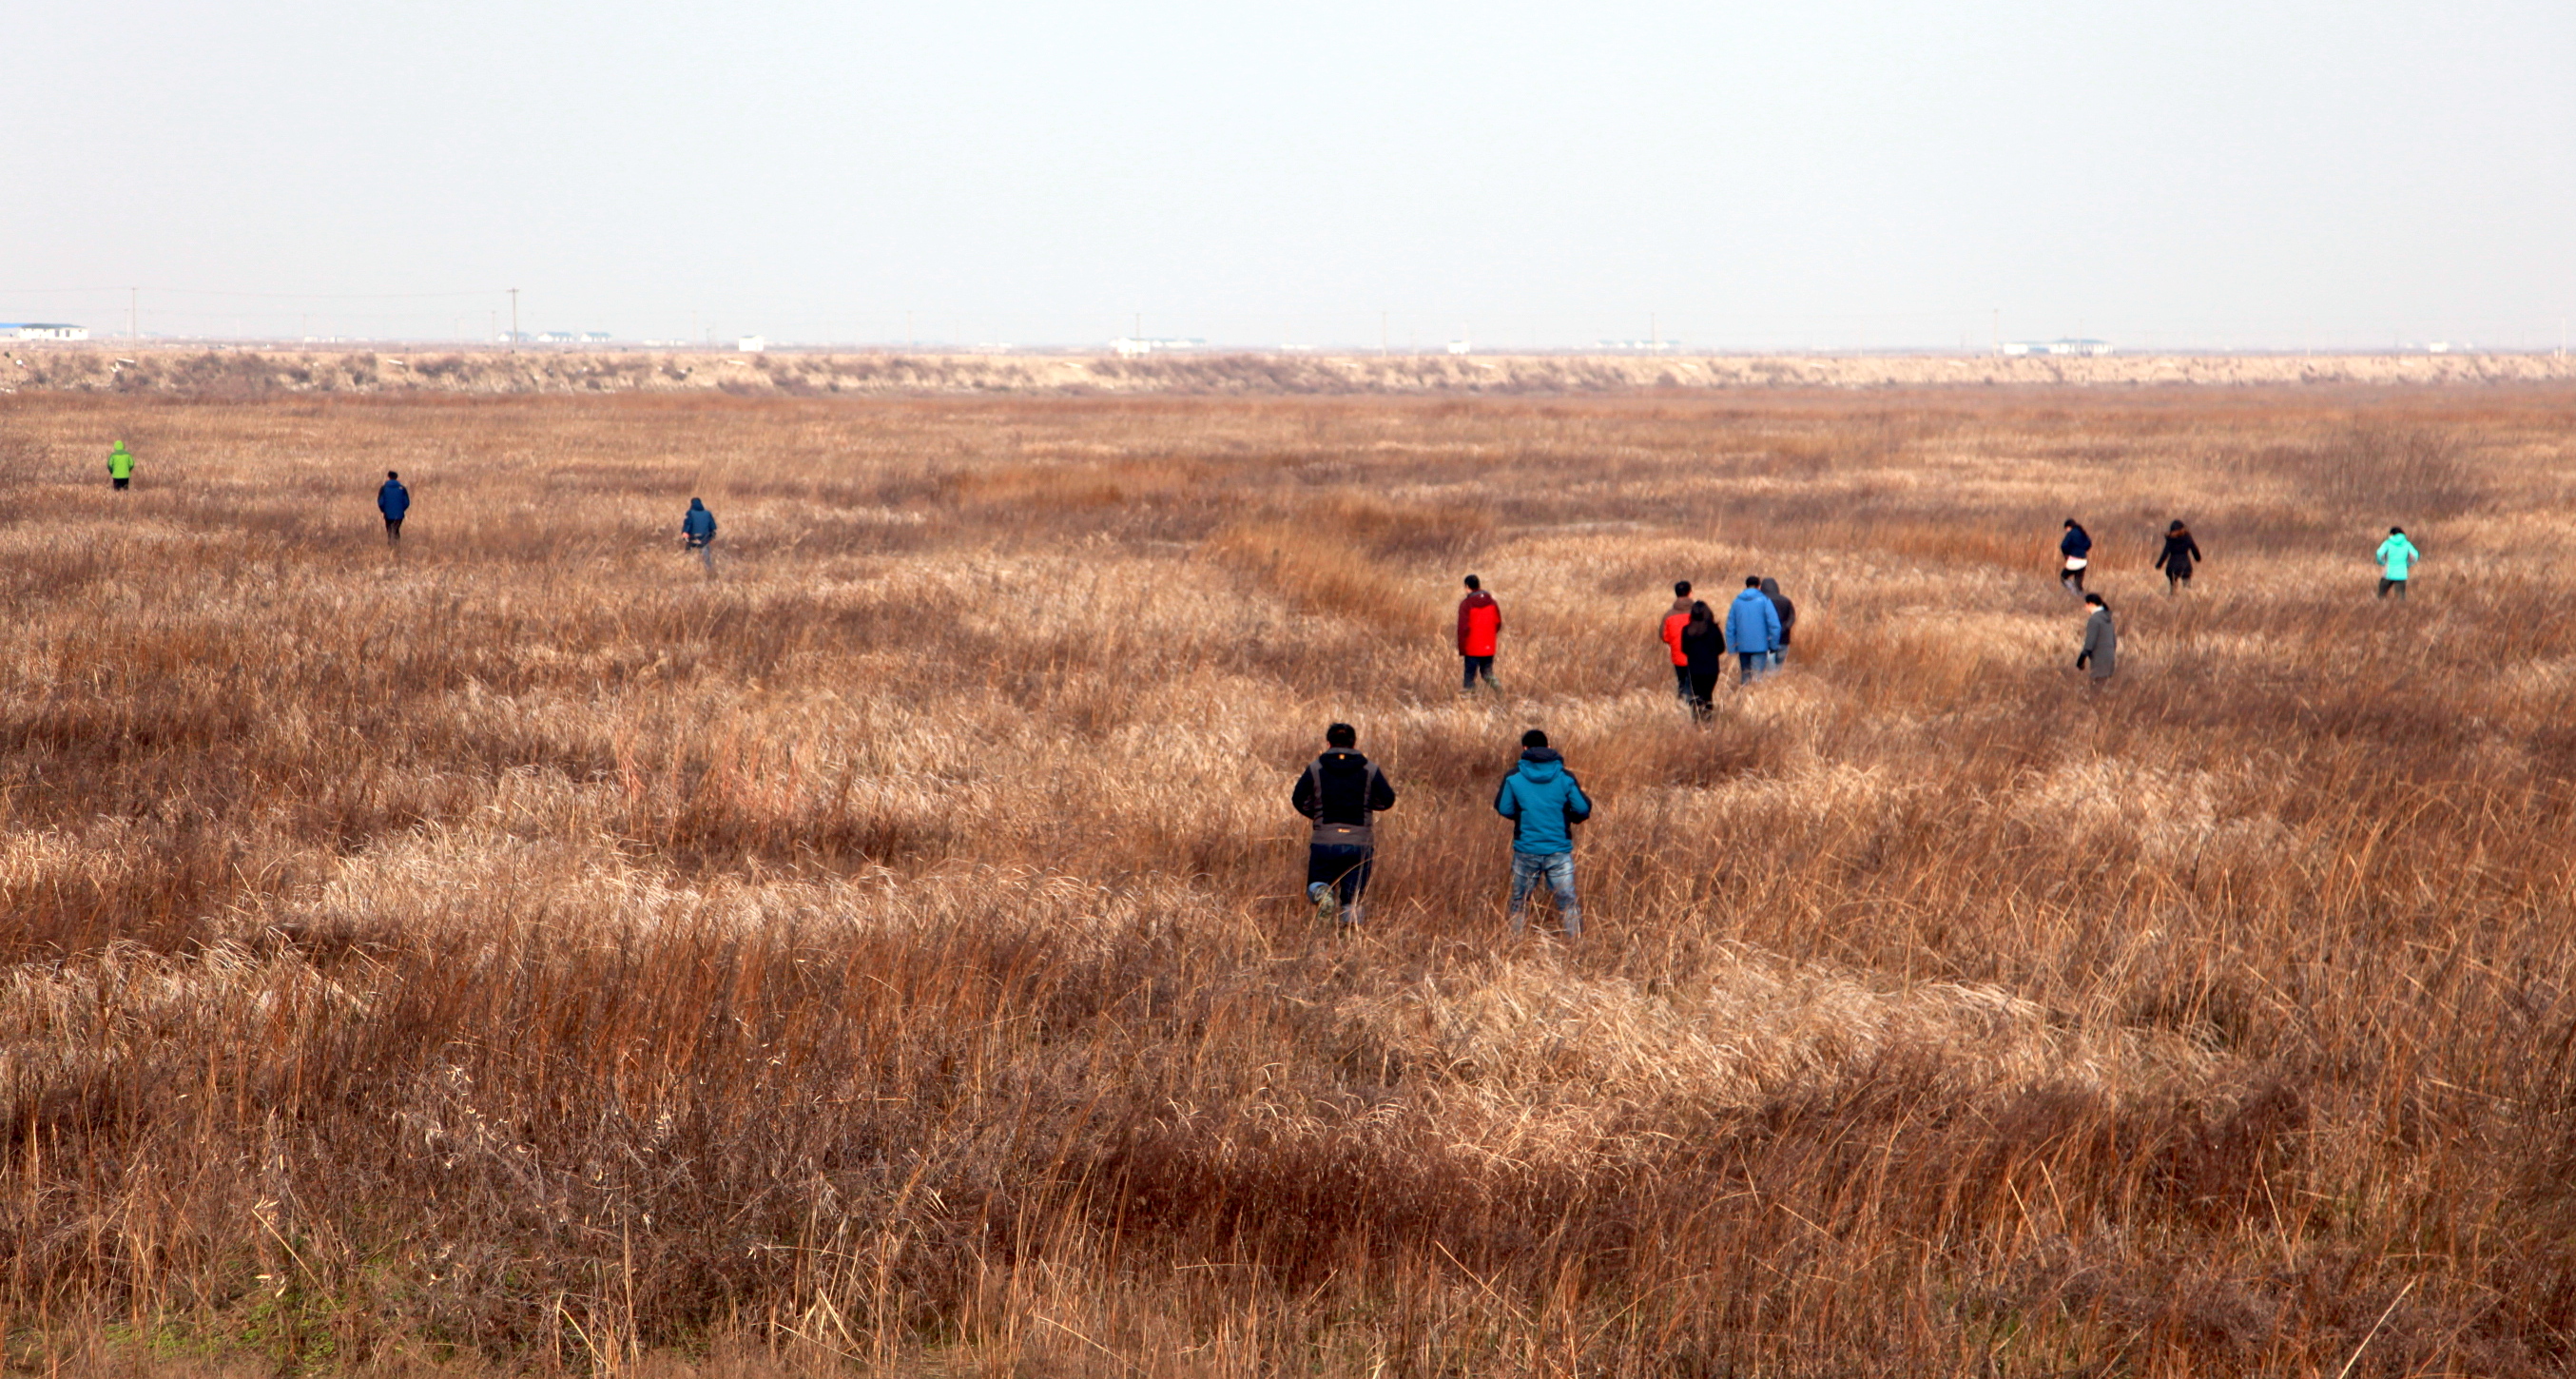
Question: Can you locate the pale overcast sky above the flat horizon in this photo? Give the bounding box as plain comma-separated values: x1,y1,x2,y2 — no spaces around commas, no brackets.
0,0,2576,348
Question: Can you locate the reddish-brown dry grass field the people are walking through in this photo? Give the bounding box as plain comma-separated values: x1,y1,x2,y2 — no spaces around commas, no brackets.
0,384,2576,1379
